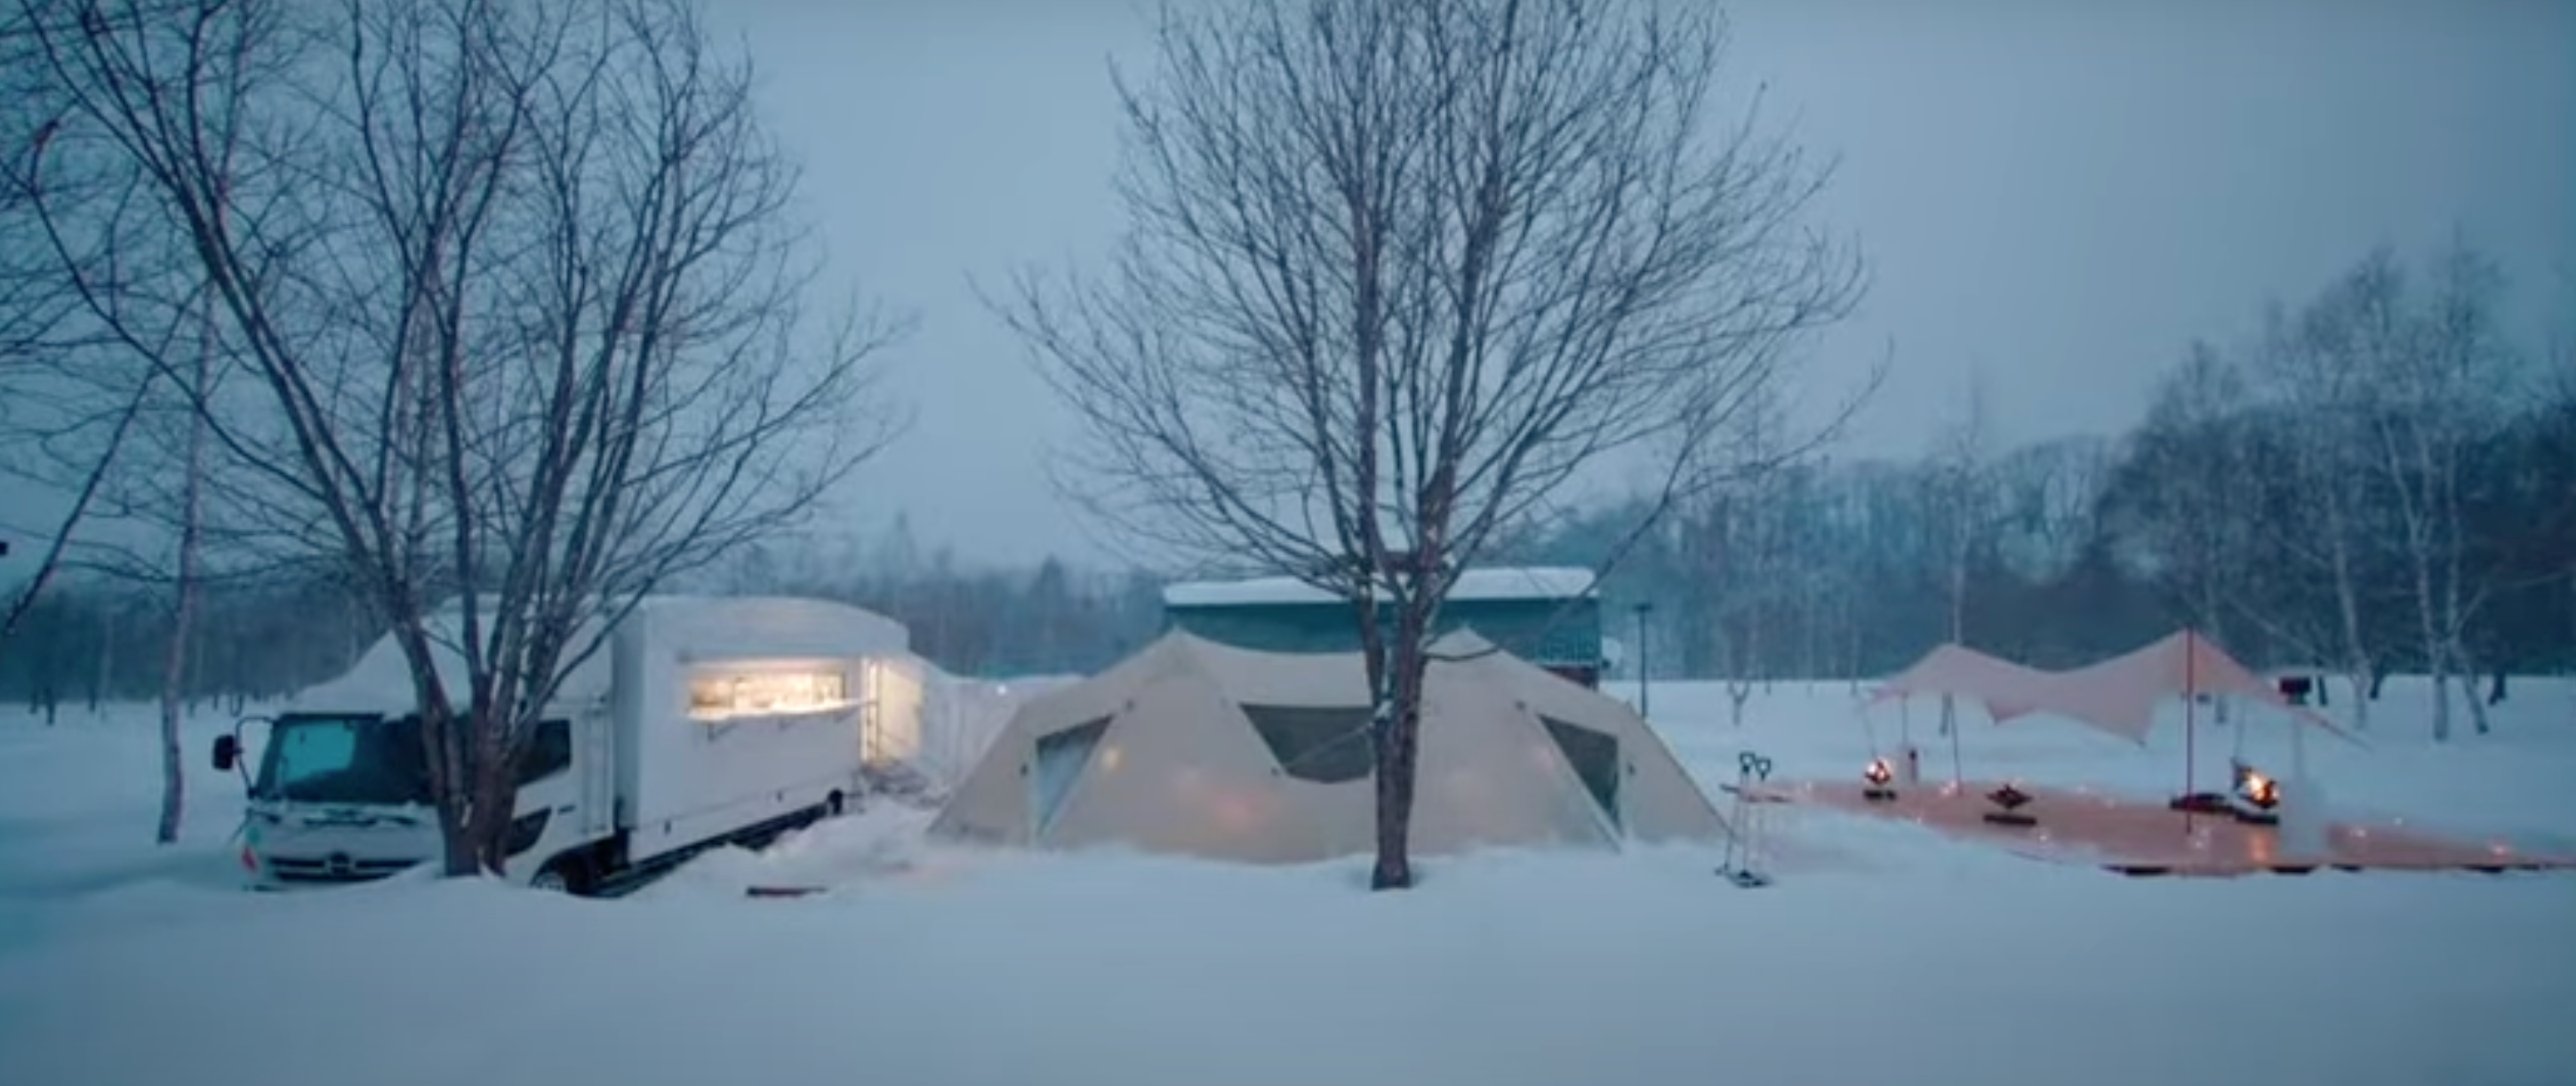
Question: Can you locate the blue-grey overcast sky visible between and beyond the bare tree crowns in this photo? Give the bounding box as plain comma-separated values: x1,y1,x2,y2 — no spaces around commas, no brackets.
11,0,2576,573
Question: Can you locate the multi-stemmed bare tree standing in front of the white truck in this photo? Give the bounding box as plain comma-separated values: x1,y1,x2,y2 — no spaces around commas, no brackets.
23,0,894,873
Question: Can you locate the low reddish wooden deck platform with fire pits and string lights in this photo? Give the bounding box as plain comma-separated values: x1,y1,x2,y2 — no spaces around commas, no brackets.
1775,779,2576,875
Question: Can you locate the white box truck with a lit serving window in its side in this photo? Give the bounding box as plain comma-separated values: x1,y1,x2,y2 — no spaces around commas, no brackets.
214,597,938,893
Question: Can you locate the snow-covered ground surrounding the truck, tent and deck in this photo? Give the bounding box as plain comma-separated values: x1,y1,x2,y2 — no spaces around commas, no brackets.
0,679,2576,1086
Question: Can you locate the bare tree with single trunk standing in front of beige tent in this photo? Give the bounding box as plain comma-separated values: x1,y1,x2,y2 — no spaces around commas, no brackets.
1002,0,1860,888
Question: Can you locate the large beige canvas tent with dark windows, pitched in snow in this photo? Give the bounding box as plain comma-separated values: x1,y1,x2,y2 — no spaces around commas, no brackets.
930,630,1726,862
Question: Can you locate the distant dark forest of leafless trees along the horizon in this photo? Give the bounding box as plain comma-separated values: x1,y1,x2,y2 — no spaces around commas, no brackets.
0,250,2576,713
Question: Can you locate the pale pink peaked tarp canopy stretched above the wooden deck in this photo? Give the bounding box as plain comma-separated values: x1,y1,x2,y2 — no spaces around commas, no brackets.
1870,630,2352,744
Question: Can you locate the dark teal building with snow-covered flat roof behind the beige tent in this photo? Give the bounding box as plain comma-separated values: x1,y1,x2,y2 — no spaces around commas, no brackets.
1162,566,1603,687
